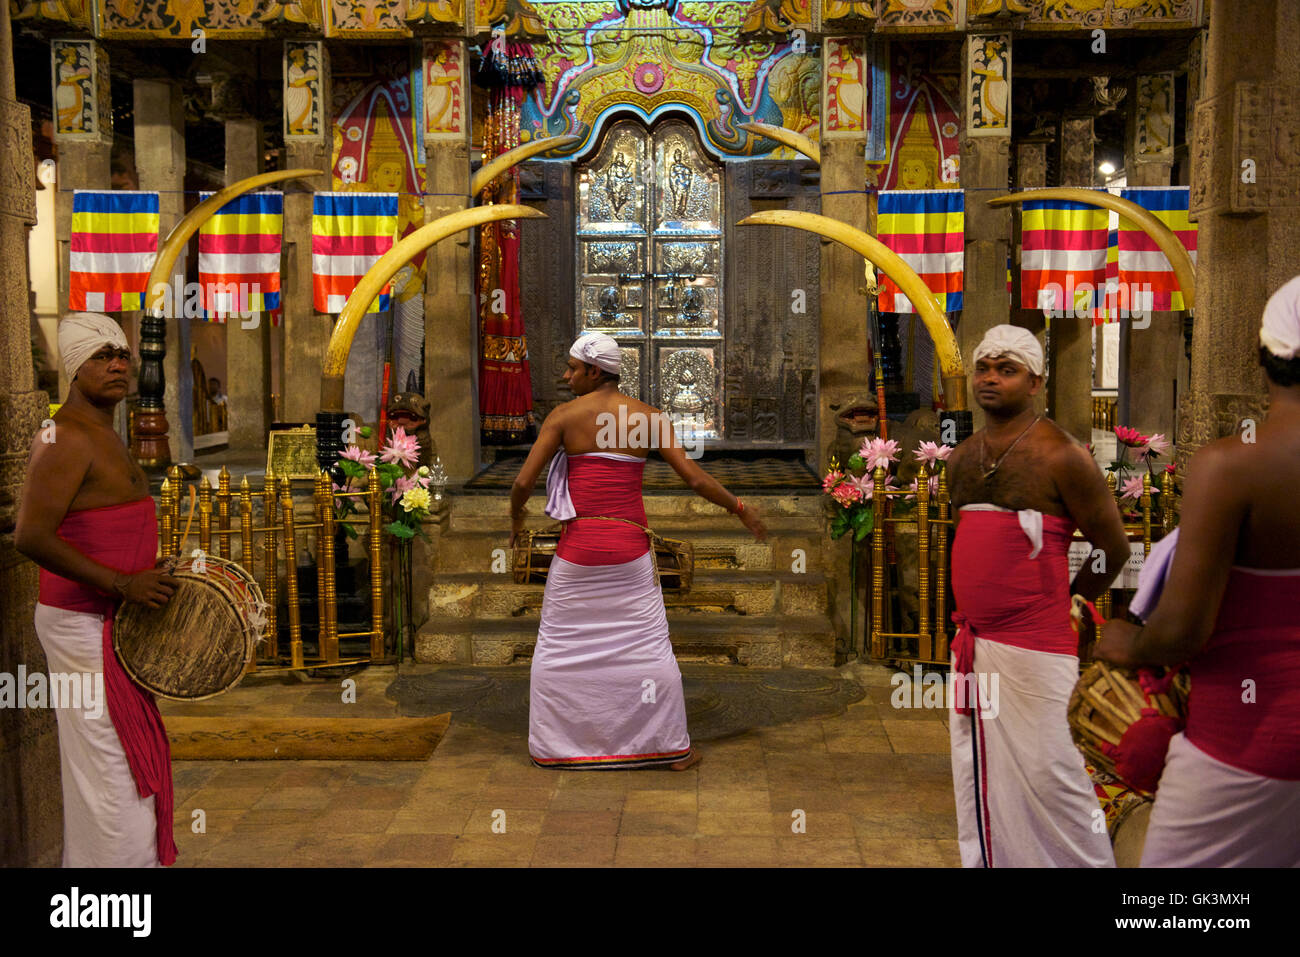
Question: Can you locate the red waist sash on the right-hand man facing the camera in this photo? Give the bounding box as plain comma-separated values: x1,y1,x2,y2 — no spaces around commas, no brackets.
953,511,1079,714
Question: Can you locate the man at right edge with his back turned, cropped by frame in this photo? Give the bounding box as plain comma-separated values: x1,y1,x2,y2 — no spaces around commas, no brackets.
1097,276,1300,867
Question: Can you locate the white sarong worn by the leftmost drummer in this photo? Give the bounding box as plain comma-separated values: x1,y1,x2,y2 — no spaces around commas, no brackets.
36,603,159,867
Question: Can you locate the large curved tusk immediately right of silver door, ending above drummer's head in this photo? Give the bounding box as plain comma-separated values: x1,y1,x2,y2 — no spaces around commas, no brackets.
738,209,966,410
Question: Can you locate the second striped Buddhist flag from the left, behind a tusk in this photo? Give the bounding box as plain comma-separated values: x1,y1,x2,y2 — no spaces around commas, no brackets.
199,192,285,324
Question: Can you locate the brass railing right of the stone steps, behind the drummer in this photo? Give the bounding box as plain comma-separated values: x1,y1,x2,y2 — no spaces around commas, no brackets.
870,465,1177,664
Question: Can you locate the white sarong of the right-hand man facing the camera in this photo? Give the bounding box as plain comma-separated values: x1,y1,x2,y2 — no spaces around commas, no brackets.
948,637,1115,867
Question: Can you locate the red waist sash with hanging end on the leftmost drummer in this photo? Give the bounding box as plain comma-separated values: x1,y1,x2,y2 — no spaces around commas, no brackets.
40,498,176,865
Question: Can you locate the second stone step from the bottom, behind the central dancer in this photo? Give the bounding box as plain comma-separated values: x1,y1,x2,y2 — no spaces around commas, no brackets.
429,568,829,620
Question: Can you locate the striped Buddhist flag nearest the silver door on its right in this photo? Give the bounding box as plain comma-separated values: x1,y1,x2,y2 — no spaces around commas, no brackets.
876,190,966,312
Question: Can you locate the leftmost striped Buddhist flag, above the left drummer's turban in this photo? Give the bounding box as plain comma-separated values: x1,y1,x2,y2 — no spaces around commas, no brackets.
68,190,159,312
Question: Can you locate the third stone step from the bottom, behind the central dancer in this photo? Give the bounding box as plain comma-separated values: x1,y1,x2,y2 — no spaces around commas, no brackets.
433,519,824,573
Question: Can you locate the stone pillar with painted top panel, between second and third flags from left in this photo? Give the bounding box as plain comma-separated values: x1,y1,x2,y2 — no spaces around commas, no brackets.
280,40,333,423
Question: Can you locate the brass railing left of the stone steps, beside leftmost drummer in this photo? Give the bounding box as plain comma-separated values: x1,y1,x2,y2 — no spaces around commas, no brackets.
159,465,385,672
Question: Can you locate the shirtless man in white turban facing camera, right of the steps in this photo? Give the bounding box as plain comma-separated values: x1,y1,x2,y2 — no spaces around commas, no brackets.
948,325,1128,867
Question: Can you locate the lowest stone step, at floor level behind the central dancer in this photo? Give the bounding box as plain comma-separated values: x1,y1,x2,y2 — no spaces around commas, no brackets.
415,611,835,668
